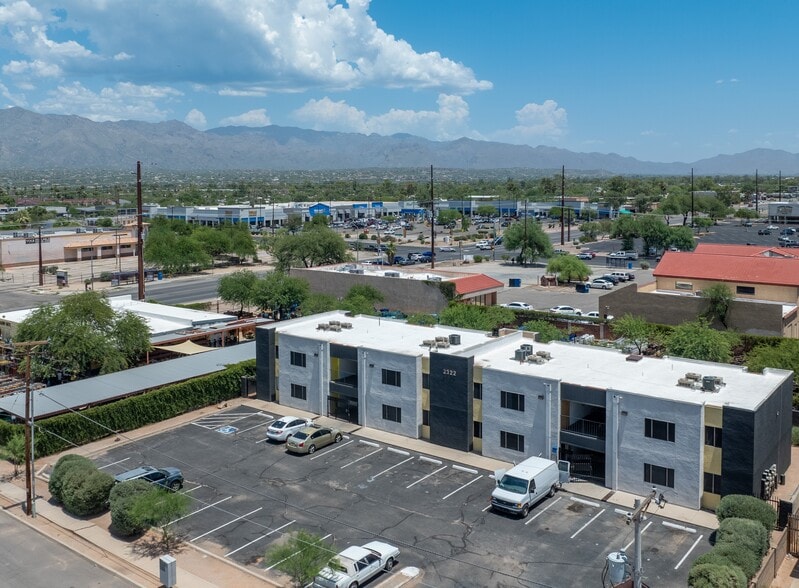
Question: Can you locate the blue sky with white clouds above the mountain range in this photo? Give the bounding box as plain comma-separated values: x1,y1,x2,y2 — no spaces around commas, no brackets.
0,0,799,167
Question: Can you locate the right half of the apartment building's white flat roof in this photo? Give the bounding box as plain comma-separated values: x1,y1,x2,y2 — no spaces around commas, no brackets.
474,337,791,410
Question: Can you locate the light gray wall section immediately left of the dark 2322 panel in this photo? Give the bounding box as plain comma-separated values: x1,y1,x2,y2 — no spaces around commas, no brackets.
358,349,422,439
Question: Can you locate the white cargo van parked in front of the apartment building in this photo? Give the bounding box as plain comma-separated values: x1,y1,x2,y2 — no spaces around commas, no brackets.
491,457,569,518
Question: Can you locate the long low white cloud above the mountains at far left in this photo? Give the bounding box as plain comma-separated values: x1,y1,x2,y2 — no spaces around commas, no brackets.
35,82,180,122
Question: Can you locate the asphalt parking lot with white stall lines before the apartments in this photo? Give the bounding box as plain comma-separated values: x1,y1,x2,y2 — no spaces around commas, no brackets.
95,405,711,586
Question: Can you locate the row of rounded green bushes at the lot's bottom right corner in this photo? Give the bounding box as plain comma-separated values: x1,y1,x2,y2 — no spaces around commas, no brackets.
688,494,777,588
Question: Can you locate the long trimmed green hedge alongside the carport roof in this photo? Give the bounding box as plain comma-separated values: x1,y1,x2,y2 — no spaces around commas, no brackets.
0,360,255,457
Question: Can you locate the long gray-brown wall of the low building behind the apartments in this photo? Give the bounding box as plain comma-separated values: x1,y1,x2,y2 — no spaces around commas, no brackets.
291,268,447,314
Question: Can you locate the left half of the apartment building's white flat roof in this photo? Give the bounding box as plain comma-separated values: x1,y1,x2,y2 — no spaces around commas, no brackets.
276,311,491,356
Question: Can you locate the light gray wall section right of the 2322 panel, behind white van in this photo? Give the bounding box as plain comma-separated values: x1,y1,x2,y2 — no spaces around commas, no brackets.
482,368,560,463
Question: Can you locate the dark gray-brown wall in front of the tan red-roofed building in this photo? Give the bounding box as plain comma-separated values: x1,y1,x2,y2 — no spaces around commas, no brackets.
599,284,783,337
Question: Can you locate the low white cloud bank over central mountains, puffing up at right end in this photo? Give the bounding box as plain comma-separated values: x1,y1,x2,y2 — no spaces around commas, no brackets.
293,94,469,141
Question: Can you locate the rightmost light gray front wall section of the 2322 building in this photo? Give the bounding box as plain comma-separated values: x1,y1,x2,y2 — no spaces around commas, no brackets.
605,391,705,509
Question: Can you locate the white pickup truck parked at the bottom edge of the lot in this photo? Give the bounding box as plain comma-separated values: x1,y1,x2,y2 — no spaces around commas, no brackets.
313,541,399,588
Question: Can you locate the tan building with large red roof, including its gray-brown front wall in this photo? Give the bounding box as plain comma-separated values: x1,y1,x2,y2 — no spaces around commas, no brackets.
599,243,799,338
